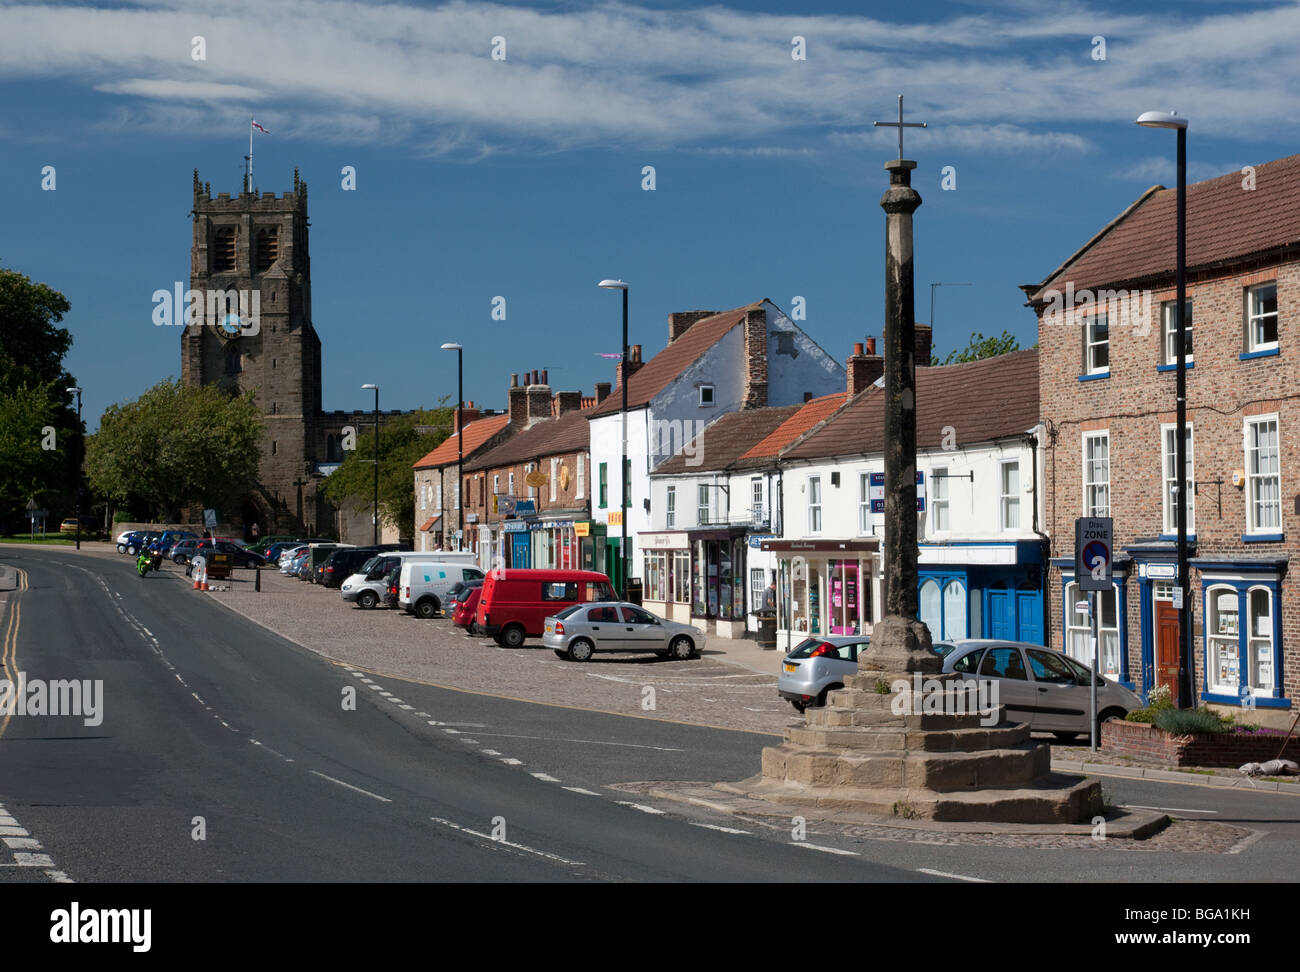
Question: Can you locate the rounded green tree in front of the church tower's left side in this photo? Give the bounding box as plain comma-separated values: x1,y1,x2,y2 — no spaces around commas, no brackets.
86,378,264,520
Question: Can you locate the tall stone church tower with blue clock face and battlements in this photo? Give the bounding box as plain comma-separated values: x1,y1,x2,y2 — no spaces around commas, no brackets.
181,169,324,533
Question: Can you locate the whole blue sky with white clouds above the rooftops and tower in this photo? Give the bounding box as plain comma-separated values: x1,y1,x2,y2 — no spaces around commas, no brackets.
0,0,1300,428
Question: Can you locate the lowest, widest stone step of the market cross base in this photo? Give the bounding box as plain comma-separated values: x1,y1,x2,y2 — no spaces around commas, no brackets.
716,773,1102,824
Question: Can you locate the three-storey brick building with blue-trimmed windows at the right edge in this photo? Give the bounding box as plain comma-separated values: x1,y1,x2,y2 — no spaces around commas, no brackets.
1024,156,1300,725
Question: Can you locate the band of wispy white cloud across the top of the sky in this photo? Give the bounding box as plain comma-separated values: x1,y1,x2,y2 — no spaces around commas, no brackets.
0,0,1300,157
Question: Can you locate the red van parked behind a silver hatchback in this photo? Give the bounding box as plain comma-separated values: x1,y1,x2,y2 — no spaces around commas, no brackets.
475,568,618,648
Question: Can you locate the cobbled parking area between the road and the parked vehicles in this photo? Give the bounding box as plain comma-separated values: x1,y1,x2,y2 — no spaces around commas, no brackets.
189,564,802,734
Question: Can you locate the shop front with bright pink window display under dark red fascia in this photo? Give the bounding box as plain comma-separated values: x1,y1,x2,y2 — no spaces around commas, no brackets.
761,539,881,650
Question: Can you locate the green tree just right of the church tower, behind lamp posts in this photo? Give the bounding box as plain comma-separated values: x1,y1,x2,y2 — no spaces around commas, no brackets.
321,398,455,537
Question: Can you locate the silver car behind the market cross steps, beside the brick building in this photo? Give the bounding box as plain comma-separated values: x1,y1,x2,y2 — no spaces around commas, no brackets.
935,638,1141,741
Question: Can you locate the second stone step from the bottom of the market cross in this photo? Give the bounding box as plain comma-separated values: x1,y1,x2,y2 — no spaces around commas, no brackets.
763,742,1052,793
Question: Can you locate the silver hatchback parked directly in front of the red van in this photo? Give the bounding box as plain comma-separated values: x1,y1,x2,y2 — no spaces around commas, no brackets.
542,600,705,661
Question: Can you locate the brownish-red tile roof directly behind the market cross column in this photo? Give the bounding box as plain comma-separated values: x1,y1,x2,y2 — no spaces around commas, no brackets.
781,348,1039,459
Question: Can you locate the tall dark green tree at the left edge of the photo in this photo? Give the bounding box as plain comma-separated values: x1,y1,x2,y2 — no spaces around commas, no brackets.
0,266,81,518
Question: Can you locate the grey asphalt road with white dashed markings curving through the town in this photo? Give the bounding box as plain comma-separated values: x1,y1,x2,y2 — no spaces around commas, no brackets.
0,550,1300,882
